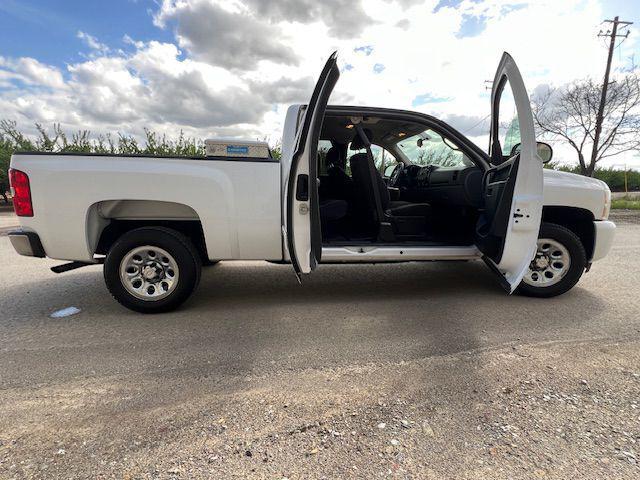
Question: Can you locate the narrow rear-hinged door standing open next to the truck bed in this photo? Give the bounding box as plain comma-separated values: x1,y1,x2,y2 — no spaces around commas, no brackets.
284,52,340,280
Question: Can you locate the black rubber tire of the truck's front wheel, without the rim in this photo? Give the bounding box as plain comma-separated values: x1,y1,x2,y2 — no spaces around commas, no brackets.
518,223,587,298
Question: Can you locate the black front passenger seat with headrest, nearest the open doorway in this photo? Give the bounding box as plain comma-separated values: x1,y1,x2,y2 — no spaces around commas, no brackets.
349,129,431,235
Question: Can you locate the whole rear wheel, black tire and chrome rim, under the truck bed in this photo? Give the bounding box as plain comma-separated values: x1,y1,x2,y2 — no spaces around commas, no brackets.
104,227,201,313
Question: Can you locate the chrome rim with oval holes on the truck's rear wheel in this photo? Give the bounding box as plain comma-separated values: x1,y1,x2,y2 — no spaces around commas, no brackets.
120,245,180,301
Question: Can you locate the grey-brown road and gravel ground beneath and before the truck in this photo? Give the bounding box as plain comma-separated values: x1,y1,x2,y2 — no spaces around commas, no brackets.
0,215,640,478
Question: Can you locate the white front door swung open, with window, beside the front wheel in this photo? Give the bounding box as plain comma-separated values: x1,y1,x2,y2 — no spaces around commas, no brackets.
476,53,543,293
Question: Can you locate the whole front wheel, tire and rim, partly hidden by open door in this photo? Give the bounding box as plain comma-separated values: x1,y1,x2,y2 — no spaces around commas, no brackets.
518,223,587,297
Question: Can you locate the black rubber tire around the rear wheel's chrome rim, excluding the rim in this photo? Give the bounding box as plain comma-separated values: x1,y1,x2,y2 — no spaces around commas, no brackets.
104,227,201,313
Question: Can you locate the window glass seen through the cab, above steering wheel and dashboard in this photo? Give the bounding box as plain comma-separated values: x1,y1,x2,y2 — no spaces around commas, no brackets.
397,129,473,167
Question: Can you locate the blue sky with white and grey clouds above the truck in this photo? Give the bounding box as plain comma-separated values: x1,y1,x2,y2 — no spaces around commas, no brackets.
0,0,640,165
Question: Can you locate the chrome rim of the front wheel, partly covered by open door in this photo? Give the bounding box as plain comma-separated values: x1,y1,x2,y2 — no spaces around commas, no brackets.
523,238,571,287
